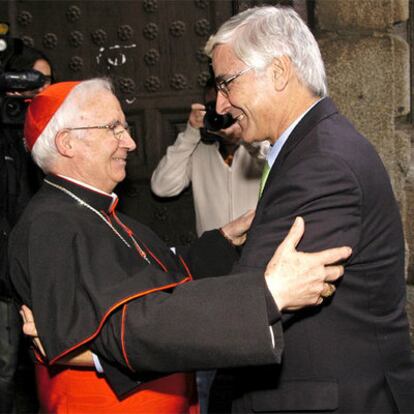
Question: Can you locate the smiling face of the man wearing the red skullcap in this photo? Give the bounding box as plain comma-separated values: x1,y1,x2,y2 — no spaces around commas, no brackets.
73,91,136,193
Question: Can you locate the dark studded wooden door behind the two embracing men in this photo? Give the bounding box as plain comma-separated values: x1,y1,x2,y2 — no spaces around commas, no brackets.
0,0,306,244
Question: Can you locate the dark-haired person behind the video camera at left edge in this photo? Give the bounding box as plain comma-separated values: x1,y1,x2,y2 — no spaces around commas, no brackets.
0,41,52,413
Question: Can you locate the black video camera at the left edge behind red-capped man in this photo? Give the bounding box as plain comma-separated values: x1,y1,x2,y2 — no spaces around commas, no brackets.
0,22,46,125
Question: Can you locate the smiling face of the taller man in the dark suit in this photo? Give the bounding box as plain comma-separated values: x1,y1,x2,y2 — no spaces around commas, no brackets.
213,44,280,142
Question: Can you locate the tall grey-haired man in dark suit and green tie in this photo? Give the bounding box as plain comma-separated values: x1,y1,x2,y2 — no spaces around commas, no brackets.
206,7,414,413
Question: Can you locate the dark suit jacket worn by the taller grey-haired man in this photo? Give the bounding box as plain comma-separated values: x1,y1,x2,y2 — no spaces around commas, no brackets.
226,98,414,413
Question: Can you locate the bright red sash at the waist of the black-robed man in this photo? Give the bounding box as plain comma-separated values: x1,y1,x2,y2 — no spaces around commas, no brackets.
36,364,199,414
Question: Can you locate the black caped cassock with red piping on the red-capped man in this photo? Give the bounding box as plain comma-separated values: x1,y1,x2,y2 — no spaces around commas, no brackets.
9,175,282,394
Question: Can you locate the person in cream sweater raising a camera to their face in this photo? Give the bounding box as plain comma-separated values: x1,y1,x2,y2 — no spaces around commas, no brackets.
151,79,268,236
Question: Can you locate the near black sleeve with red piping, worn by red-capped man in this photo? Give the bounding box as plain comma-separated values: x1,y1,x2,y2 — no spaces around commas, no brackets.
91,272,281,374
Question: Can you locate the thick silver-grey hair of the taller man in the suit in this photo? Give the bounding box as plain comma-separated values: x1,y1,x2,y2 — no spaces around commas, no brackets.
204,6,328,97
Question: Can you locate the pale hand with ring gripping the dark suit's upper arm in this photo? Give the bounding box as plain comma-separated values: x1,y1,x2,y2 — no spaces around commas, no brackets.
265,217,352,311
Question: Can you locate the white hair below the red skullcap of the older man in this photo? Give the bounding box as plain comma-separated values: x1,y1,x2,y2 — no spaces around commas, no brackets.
32,78,113,173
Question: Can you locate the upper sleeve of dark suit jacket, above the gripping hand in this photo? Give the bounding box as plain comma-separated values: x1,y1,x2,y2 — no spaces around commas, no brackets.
235,153,363,271
